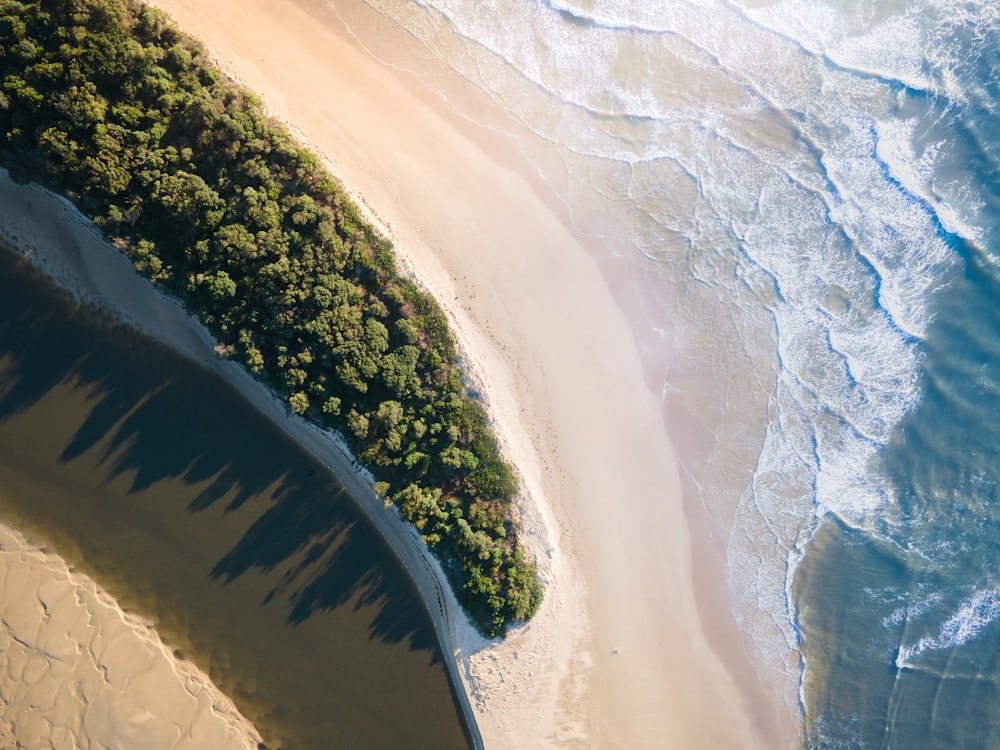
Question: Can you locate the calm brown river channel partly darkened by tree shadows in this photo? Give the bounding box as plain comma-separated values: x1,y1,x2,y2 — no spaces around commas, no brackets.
0,252,469,749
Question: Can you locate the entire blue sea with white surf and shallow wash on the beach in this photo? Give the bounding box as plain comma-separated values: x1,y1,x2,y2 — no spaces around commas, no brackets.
326,0,1000,748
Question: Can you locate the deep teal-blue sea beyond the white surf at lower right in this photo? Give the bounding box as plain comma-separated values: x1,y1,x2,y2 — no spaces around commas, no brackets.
793,256,1000,748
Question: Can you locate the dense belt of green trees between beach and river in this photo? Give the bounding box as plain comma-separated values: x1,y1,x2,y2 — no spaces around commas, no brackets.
0,0,541,634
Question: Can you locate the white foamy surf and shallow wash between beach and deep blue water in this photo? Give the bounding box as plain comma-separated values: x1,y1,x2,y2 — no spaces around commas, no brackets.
358,0,1000,712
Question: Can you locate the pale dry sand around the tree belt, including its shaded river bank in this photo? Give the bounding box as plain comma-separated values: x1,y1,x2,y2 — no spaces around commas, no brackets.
0,0,795,748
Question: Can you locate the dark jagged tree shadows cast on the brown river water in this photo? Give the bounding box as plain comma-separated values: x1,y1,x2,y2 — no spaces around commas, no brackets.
0,251,441,664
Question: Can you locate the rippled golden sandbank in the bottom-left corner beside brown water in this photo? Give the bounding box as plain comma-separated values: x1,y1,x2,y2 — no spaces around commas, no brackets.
0,524,260,750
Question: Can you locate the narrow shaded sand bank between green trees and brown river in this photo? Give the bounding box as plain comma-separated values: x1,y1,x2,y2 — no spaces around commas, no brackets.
0,169,486,750
